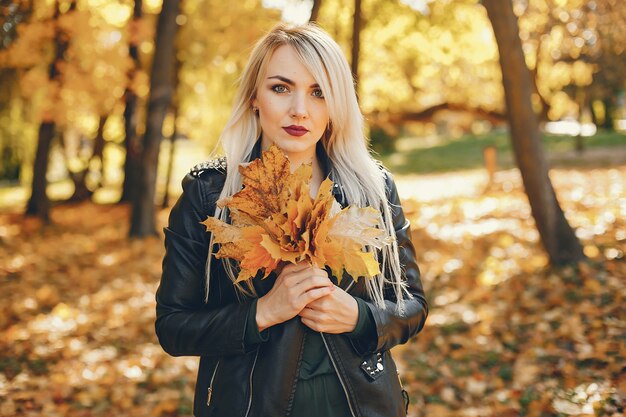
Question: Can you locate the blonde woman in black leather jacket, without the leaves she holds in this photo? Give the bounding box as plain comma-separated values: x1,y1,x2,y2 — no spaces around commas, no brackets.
156,24,428,417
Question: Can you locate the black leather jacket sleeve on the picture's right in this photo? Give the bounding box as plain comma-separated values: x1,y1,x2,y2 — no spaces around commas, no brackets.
353,171,428,353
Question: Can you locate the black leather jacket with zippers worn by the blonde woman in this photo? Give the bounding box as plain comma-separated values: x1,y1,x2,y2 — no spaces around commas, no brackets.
156,148,428,417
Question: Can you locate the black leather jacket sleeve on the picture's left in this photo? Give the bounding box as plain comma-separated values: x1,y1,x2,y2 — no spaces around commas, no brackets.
155,172,258,356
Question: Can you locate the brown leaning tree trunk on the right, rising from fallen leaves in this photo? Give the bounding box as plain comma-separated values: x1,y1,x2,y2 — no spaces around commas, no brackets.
483,0,585,265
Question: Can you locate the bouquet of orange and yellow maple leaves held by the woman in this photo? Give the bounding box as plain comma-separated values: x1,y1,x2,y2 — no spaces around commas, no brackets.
202,145,390,282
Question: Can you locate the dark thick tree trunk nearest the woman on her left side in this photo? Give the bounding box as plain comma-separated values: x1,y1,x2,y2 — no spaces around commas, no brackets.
130,0,180,237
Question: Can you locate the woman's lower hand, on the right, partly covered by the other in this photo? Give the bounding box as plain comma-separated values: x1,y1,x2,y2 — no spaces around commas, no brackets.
300,287,359,334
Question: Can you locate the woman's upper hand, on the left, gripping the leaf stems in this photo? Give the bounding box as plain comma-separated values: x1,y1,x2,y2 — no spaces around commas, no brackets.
256,262,335,331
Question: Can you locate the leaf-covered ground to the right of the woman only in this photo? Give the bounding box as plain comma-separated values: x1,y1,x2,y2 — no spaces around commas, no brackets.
396,168,626,417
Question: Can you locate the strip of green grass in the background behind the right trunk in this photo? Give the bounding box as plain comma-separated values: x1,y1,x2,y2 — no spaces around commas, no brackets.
378,131,626,174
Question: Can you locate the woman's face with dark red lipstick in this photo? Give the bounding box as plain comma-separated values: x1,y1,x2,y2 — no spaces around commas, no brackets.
252,45,329,162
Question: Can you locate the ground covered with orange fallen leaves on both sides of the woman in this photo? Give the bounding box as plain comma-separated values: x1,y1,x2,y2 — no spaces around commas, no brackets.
0,167,626,417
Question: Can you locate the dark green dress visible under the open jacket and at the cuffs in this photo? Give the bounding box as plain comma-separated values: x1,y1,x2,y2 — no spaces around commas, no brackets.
245,297,376,417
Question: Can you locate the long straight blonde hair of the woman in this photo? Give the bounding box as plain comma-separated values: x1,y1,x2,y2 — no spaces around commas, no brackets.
205,23,411,311
